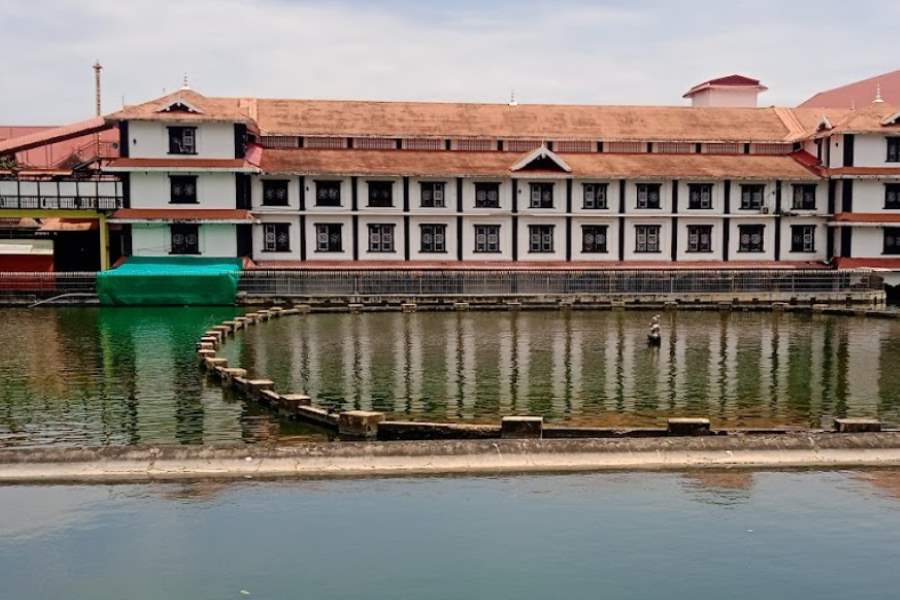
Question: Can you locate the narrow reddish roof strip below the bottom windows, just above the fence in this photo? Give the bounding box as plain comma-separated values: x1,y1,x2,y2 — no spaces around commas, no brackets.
251,260,829,271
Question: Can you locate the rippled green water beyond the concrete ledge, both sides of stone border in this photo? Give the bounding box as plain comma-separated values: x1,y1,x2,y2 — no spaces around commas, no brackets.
0,308,900,447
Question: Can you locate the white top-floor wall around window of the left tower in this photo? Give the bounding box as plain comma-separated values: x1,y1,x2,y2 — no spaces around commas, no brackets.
128,121,234,159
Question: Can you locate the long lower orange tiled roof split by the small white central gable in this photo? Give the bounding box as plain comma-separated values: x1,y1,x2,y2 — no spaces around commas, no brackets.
260,149,819,181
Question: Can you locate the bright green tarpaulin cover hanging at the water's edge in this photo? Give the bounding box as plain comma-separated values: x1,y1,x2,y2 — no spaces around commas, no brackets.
97,256,241,306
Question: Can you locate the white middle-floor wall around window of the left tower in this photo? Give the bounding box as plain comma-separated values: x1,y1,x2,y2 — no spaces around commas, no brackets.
131,172,235,209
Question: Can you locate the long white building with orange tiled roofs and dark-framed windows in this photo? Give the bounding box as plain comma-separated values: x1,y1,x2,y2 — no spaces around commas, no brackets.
0,76,900,278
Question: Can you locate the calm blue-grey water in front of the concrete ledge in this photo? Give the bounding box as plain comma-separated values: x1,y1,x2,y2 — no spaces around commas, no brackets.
0,471,900,600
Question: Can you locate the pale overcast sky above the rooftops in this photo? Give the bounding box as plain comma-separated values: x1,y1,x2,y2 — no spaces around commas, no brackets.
0,0,900,124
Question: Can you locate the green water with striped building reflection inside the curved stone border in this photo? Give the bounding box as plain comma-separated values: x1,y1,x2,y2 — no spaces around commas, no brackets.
233,312,900,427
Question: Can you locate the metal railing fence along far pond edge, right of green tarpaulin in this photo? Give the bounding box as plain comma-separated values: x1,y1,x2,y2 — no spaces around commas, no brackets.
239,270,883,297
